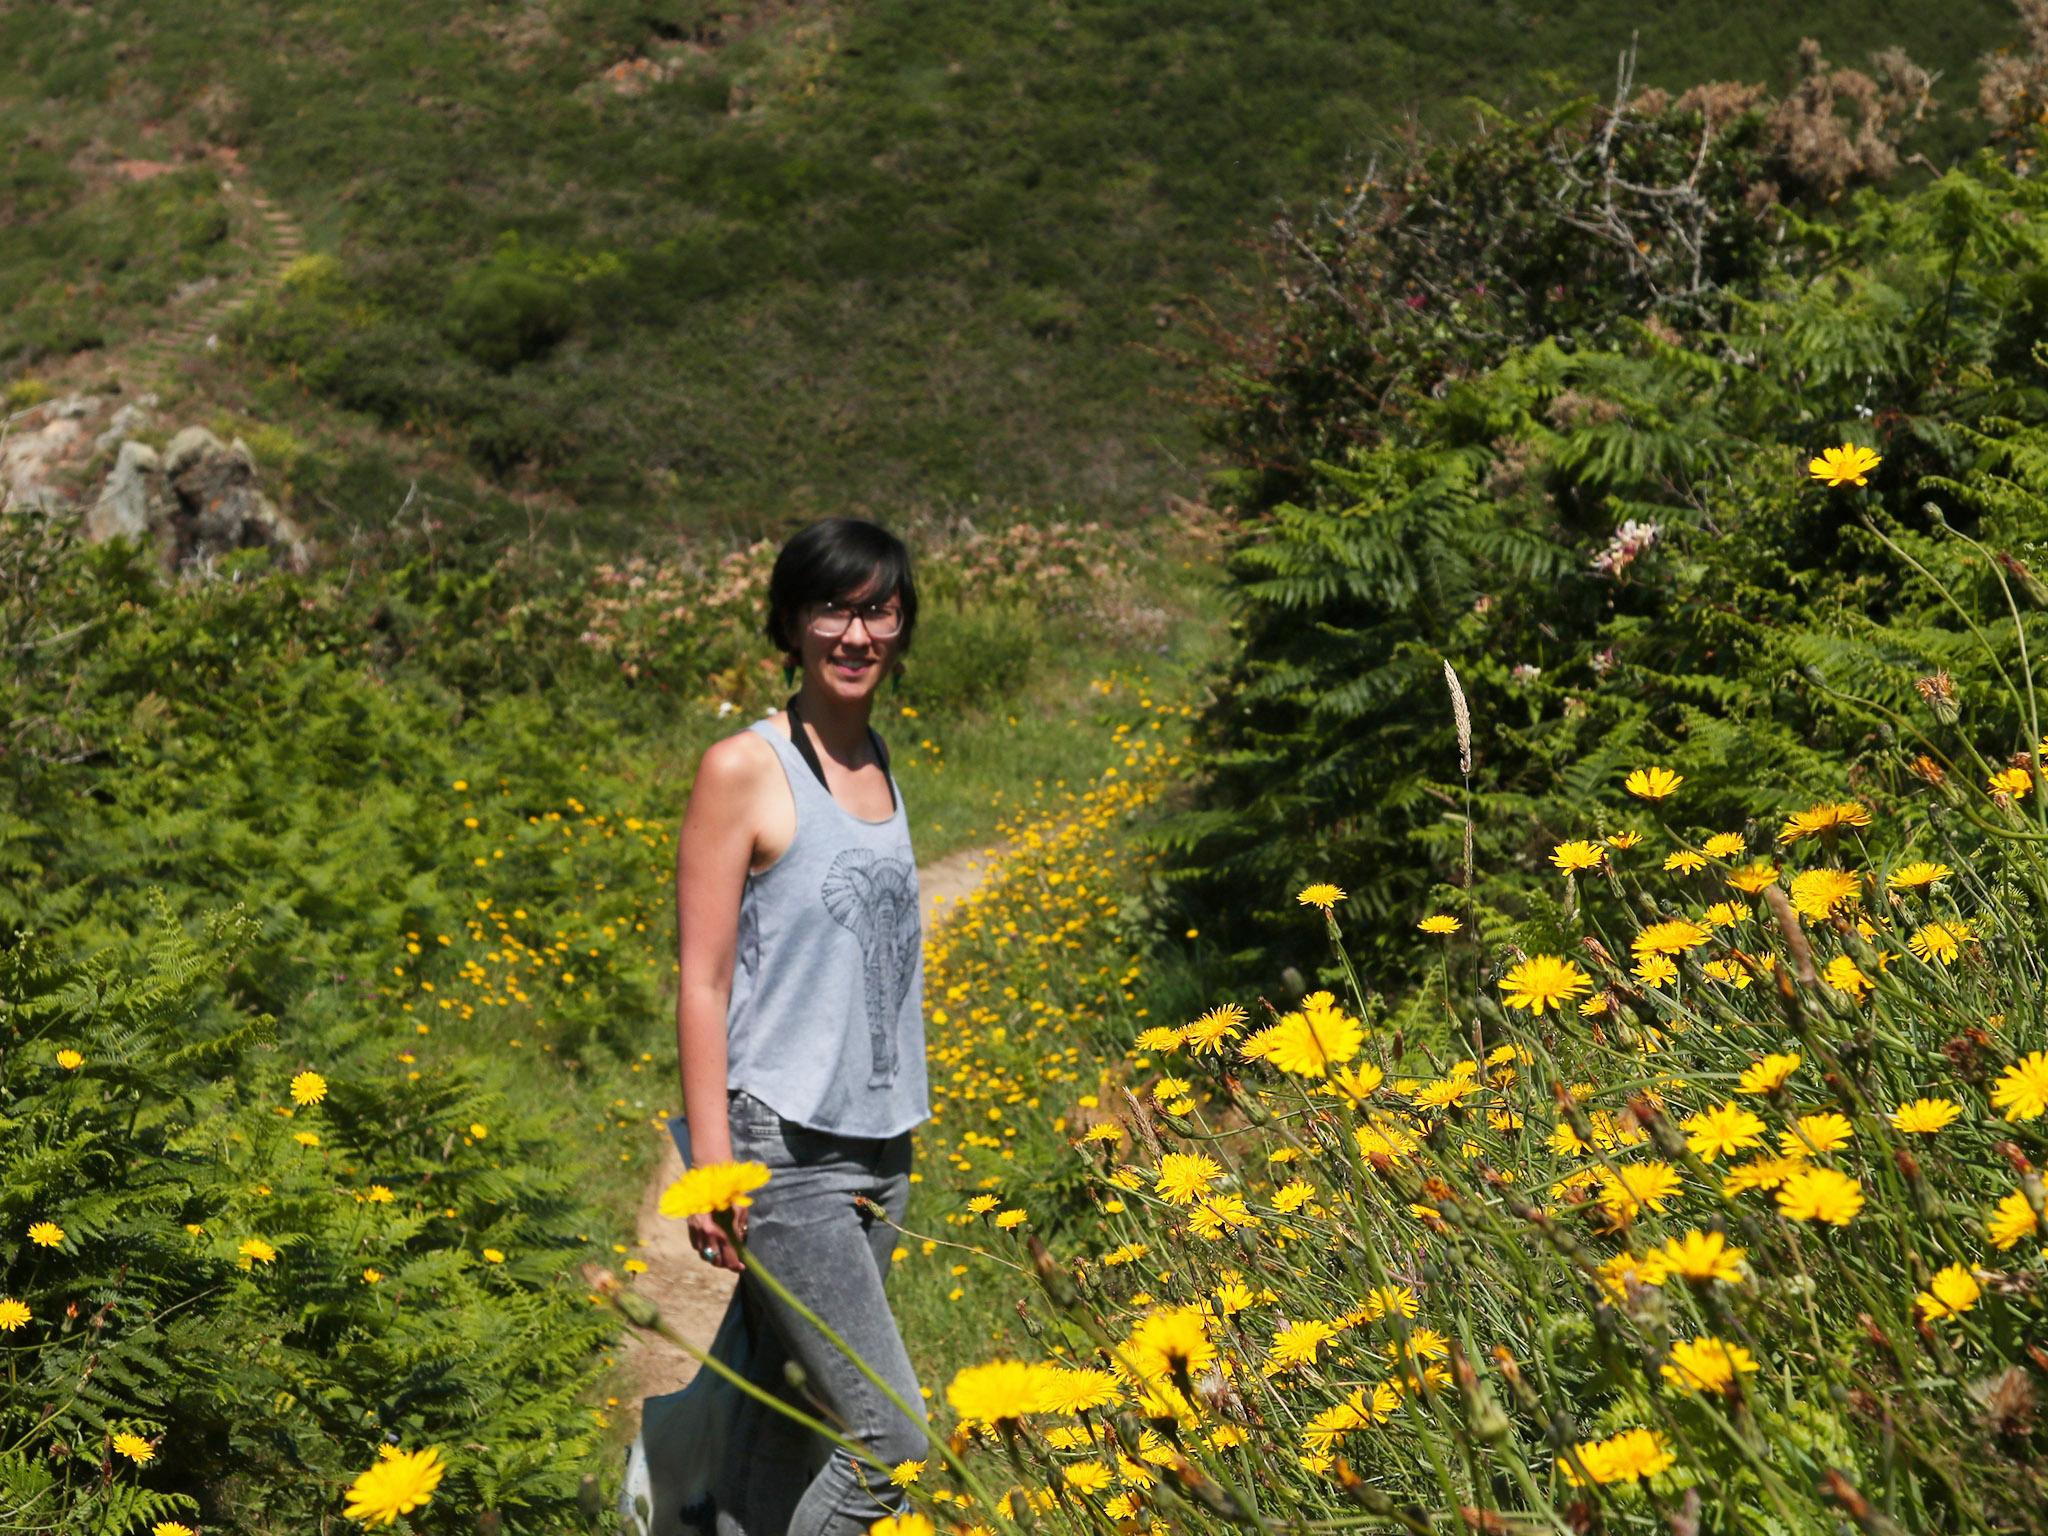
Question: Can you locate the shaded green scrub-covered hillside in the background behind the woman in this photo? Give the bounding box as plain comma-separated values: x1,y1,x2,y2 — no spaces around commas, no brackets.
0,0,2013,537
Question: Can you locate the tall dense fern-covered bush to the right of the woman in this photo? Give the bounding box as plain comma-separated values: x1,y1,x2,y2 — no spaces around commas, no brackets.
1171,90,2048,999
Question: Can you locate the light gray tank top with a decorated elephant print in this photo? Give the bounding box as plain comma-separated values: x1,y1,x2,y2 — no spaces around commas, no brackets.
725,719,932,1137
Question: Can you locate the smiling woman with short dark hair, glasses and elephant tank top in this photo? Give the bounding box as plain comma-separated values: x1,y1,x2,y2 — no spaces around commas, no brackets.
676,518,932,1536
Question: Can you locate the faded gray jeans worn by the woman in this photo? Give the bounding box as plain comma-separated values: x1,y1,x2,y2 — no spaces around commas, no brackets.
717,1090,930,1536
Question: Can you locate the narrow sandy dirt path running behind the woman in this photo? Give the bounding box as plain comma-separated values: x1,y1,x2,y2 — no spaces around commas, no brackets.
610,848,1001,1440
